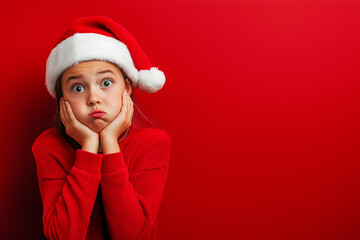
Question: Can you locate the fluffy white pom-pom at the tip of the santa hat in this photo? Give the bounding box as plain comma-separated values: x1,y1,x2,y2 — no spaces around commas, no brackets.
138,67,165,93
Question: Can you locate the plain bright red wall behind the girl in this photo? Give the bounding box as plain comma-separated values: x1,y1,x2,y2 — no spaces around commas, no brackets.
0,0,360,240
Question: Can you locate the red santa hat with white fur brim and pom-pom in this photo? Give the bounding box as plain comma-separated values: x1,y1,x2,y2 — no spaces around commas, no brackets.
46,16,165,98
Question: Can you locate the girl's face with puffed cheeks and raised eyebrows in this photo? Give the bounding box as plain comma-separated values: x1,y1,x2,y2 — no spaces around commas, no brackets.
61,60,132,133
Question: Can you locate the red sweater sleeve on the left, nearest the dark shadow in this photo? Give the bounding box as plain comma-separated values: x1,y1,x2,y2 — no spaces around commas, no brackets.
32,132,102,239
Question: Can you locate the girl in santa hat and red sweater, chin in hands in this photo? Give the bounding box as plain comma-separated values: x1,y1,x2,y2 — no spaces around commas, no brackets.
32,16,171,239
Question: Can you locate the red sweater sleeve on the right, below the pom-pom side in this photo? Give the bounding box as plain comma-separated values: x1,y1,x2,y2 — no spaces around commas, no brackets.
100,128,171,240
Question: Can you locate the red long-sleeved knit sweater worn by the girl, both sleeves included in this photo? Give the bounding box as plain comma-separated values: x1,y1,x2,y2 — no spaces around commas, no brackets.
32,127,171,240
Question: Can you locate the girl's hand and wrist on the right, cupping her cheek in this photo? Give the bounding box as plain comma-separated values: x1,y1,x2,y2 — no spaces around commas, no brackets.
100,90,134,154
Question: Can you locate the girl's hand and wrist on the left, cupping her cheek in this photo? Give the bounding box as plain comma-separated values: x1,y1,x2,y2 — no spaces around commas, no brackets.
60,98,99,153
